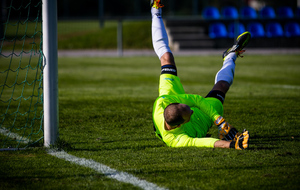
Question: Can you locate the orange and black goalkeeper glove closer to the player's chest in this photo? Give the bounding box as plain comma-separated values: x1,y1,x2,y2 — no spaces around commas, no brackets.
215,116,241,141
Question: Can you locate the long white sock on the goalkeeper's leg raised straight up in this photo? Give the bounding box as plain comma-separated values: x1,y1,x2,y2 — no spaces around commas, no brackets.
151,7,172,59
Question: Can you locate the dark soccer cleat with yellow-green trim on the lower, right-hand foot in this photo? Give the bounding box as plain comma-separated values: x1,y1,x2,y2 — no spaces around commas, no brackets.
223,31,251,59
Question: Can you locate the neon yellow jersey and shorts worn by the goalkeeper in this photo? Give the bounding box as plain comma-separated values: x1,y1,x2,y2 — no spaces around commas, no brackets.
153,74,223,148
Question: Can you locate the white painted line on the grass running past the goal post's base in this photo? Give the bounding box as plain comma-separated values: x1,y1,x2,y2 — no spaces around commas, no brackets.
0,128,167,190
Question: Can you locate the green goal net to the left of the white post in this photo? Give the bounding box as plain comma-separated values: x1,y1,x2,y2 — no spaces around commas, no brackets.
0,0,43,149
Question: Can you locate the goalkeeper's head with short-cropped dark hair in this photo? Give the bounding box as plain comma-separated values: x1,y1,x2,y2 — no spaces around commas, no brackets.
164,103,194,130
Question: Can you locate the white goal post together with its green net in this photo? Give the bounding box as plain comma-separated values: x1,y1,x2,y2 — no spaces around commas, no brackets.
0,0,59,150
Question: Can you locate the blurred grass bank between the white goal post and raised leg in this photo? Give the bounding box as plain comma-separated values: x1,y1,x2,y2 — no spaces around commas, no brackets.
58,21,152,49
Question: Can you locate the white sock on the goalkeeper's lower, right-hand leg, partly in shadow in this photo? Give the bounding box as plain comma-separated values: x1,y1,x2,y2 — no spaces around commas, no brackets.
215,52,237,85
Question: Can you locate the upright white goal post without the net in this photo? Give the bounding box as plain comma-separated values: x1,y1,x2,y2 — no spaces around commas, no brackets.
42,0,59,147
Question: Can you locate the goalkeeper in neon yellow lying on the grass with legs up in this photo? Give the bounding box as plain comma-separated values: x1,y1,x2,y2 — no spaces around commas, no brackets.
150,0,251,150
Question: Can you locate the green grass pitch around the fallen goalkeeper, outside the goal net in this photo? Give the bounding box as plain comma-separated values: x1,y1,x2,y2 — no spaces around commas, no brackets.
0,55,300,190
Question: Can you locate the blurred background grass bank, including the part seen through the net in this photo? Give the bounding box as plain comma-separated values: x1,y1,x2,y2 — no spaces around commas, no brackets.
2,20,152,52
